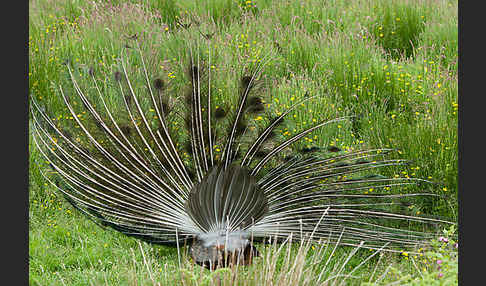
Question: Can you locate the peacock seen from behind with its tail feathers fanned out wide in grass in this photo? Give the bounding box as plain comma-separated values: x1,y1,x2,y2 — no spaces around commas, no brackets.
31,44,449,268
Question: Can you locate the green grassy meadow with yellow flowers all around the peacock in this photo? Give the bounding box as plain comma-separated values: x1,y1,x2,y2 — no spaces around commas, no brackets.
29,0,458,285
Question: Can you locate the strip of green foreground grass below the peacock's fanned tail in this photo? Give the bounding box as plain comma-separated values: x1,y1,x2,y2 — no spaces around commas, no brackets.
29,203,457,286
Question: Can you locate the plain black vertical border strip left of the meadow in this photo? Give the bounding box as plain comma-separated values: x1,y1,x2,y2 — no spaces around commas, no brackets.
8,1,29,285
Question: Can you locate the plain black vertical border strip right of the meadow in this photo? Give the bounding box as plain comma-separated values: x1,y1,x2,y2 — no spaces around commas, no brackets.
457,1,474,285
